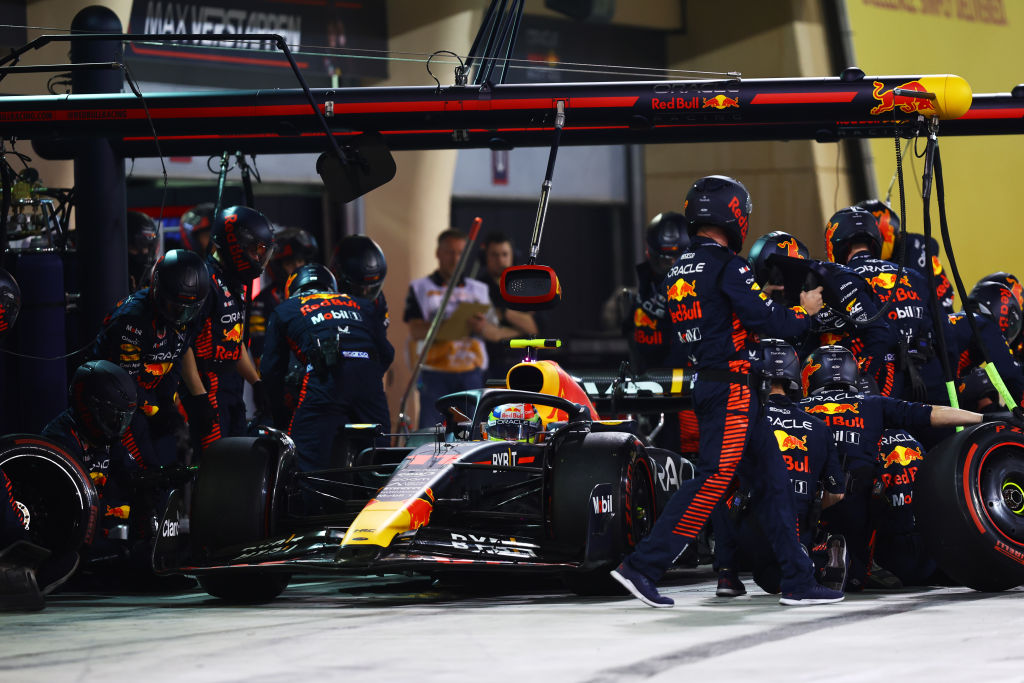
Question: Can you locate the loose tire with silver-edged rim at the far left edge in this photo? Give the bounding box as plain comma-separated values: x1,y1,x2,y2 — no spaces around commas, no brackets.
0,434,99,556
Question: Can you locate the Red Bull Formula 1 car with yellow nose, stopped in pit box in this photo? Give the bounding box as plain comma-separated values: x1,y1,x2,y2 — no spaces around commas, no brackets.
154,361,692,601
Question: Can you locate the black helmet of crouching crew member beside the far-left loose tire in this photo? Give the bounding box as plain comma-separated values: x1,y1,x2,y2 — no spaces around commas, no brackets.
69,360,138,445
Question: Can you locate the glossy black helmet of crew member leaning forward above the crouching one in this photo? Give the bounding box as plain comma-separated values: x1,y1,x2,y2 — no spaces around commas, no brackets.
150,249,210,325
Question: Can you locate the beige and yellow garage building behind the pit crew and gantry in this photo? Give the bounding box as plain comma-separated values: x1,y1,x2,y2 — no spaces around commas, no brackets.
0,0,1024,431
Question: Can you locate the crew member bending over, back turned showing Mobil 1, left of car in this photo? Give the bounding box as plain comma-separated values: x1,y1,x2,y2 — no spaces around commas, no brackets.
260,263,394,471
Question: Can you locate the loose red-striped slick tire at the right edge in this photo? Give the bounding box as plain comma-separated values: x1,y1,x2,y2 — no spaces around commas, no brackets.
913,422,1024,591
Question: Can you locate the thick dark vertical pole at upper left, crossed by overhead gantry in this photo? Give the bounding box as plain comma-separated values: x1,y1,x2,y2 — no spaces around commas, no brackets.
71,5,128,339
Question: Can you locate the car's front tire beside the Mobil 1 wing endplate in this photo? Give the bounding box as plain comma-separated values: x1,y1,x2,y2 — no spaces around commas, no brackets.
550,432,656,595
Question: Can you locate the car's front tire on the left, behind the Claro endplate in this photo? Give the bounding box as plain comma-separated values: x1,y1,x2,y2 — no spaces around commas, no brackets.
191,437,290,603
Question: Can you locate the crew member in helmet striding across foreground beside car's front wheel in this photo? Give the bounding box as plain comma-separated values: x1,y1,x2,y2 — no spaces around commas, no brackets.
611,176,843,607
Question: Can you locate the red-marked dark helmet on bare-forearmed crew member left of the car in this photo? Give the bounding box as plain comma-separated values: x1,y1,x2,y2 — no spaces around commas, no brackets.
210,206,275,283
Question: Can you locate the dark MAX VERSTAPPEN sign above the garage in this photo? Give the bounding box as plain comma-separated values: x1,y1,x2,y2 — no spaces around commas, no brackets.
126,0,387,88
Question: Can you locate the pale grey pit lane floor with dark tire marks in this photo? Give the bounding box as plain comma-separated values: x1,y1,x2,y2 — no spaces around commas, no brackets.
0,571,1024,683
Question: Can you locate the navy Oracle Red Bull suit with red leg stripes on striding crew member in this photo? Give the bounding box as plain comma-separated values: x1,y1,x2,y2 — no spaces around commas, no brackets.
625,236,814,592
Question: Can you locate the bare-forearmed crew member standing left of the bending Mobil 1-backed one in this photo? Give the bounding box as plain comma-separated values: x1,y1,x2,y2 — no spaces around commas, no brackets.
181,206,274,457
